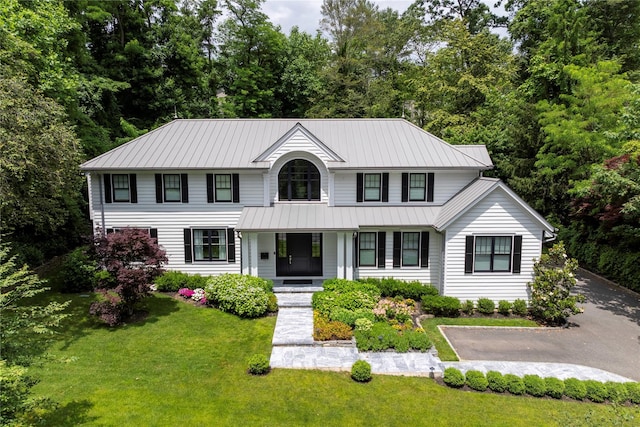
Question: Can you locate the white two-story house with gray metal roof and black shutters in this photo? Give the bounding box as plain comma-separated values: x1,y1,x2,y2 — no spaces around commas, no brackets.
81,119,554,300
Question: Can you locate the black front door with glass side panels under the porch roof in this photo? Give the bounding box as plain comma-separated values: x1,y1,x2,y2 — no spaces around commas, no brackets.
276,233,322,276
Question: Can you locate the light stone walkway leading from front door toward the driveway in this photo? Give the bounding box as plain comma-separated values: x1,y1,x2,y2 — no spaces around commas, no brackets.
270,285,632,382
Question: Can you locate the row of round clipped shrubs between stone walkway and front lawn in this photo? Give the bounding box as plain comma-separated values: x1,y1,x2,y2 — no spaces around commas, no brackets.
443,367,640,404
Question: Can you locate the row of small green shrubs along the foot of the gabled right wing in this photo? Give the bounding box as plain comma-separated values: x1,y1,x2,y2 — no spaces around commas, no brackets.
422,295,527,317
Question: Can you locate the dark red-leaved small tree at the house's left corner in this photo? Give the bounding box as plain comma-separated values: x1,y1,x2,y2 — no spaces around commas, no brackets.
90,228,167,326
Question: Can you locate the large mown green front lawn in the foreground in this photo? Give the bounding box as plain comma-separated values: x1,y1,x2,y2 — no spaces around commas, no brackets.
27,295,640,427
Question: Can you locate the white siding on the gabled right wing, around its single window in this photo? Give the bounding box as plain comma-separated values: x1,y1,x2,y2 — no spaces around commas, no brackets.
443,188,543,301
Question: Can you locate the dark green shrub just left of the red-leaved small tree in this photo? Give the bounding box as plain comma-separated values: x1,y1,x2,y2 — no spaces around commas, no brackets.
55,247,97,292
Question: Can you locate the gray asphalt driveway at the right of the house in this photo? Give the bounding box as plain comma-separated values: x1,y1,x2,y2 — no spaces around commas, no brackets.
442,272,640,381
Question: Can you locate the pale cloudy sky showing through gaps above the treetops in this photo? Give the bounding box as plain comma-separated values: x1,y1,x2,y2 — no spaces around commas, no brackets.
262,0,413,35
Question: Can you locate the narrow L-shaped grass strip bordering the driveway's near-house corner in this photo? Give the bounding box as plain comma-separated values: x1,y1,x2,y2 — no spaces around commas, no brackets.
421,317,538,361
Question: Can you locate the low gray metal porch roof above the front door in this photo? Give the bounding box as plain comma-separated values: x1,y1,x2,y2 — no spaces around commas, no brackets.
236,203,441,232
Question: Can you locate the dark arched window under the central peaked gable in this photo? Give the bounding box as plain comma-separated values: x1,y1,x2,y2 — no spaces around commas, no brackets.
278,159,320,200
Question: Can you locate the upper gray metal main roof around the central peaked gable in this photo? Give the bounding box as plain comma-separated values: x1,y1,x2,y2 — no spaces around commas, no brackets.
81,119,493,170
